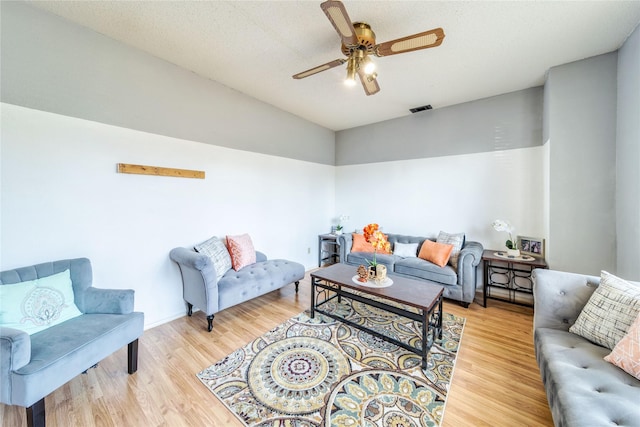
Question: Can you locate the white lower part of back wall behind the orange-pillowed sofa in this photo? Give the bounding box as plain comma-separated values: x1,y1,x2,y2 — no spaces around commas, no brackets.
336,146,546,249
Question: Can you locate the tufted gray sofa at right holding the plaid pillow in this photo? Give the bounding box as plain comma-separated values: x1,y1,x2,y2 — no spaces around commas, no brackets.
533,269,640,427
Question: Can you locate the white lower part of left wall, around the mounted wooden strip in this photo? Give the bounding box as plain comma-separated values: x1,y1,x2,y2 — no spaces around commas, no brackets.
0,103,334,327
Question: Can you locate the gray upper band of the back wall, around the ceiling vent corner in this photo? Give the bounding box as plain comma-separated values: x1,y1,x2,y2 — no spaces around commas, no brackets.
336,87,543,166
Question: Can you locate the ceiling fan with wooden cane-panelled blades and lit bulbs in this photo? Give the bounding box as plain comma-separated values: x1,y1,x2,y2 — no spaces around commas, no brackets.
293,0,444,95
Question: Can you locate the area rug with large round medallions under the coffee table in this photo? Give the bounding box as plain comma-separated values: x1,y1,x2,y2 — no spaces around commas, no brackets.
197,302,465,427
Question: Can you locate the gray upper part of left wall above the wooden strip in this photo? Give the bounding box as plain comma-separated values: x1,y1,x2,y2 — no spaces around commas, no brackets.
0,1,335,165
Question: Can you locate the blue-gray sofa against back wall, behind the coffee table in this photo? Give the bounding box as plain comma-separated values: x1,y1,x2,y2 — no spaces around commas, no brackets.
338,233,483,307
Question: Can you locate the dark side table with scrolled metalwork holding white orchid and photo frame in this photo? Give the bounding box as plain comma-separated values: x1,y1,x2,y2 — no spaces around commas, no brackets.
482,249,548,307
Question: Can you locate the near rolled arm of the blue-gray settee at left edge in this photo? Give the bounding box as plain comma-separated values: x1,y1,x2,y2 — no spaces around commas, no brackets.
0,326,31,405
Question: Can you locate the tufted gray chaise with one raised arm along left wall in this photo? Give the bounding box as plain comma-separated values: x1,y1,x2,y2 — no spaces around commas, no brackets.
169,247,305,332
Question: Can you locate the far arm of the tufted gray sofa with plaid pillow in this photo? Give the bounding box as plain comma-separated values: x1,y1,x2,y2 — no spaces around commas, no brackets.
532,269,600,331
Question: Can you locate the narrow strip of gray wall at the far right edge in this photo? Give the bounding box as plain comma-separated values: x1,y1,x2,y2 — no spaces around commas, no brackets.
616,26,640,281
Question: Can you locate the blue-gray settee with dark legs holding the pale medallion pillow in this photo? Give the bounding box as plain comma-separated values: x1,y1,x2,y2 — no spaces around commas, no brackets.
0,258,144,426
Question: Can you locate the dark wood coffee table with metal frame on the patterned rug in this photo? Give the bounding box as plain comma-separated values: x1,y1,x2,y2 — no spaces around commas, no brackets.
311,263,444,369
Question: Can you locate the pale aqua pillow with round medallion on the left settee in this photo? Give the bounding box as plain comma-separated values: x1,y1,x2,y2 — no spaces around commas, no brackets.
0,270,82,335
